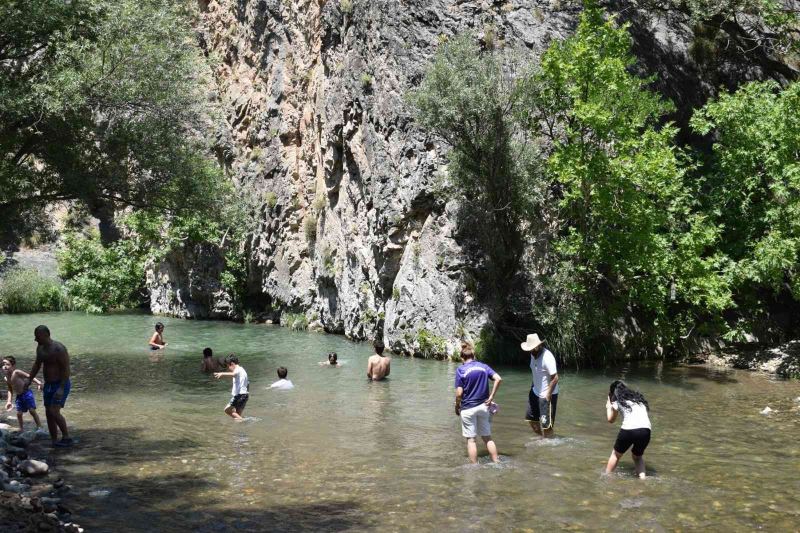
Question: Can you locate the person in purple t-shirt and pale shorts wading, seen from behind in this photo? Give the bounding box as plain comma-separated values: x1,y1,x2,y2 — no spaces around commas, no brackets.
456,342,502,463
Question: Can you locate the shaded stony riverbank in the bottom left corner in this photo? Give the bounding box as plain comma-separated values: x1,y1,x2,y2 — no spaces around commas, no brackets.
0,417,83,533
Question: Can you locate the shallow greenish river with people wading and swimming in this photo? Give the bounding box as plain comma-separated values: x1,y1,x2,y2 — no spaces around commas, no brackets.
0,313,800,532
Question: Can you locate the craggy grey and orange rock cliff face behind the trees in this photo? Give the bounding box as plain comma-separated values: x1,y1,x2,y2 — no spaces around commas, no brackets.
149,0,789,353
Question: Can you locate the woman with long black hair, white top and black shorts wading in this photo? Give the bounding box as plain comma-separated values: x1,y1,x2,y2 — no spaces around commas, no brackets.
606,380,651,479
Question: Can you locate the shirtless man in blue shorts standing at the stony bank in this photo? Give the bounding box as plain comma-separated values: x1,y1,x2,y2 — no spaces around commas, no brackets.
25,326,72,448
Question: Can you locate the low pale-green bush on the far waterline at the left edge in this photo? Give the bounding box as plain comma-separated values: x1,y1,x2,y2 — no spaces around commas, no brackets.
0,268,70,313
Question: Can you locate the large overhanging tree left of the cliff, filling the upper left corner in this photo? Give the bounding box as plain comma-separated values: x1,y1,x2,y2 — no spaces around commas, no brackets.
0,0,218,243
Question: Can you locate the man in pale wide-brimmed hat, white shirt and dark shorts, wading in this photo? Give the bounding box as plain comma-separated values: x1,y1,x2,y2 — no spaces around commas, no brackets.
521,333,558,437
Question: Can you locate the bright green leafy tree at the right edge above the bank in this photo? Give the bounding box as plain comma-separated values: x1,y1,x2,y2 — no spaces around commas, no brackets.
691,82,800,300
